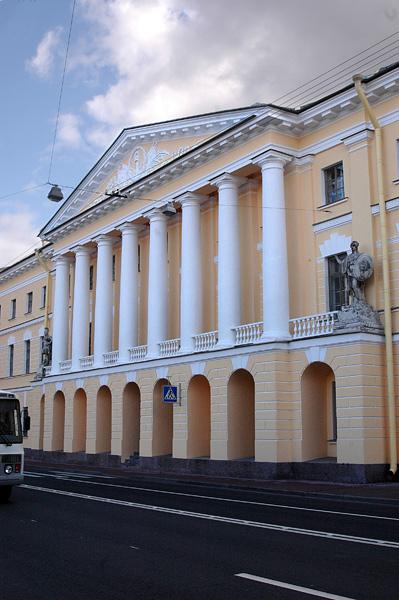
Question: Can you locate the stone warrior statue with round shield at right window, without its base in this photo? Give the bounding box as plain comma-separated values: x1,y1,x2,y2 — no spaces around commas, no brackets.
335,241,373,302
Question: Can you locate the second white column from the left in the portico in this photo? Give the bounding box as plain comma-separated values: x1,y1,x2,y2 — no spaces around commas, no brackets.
72,246,90,371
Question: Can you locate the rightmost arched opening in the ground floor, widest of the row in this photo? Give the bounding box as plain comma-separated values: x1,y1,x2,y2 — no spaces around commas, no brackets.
301,362,337,460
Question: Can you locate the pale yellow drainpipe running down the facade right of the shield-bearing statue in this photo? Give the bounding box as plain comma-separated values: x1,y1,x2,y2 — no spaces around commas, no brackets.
353,75,398,479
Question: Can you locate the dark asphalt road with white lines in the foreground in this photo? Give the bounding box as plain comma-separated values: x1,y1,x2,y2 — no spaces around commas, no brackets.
0,467,399,600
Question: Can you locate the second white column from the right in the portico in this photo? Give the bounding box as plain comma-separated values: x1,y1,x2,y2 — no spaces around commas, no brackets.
211,173,246,347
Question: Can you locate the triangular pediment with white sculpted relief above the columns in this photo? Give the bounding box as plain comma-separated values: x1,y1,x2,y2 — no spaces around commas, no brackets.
40,105,264,238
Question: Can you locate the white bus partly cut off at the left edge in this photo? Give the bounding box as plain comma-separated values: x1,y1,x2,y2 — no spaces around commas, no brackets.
0,390,30,502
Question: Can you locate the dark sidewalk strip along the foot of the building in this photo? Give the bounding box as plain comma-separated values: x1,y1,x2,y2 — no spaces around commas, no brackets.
25,460,399,504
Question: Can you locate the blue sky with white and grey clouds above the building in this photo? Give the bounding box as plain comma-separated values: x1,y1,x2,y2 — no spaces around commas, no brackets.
0,0,399,266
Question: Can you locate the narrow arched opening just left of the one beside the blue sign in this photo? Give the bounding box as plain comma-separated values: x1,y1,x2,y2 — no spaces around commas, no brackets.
122,382,140,458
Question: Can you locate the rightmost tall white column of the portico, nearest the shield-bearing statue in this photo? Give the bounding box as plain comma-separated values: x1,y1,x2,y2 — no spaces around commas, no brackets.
254,150,291,341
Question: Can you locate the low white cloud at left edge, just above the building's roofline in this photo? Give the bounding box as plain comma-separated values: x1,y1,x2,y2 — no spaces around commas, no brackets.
0,206,41,267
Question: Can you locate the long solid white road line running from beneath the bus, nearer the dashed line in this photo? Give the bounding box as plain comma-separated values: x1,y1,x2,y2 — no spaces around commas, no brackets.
20,484,399,549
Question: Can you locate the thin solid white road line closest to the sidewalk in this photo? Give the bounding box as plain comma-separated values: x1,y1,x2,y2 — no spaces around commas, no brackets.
25,471,399,521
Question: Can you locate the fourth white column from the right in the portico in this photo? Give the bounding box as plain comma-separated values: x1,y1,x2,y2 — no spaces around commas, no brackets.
147,210,168,357
